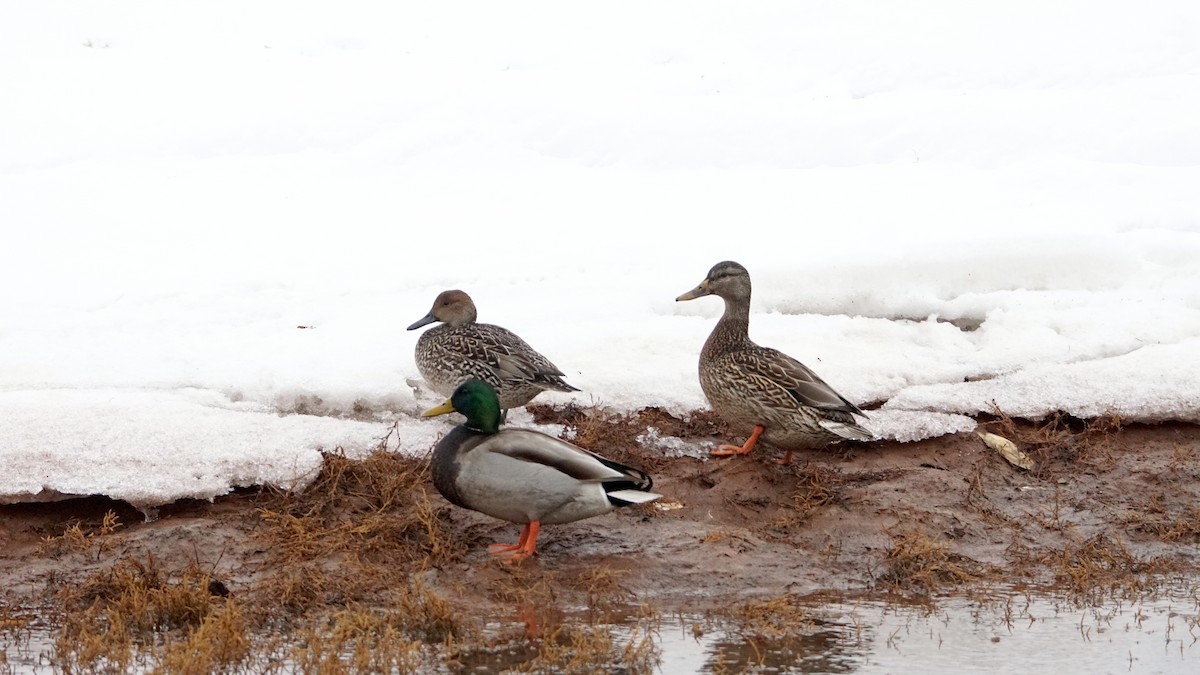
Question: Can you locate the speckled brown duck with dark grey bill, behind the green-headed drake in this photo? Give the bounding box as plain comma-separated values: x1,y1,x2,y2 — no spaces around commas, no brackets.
408,291,578,413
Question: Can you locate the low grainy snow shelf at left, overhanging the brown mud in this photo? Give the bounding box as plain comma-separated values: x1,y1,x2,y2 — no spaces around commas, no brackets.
0,389,388,507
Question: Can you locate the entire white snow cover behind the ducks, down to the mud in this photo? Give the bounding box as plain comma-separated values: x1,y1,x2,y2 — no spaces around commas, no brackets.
0,0,1200,507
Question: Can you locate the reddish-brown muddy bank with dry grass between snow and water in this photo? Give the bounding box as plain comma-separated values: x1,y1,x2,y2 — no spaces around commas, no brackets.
0,406,1200,673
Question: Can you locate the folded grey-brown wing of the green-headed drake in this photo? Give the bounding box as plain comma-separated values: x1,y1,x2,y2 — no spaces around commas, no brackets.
480,429,654,490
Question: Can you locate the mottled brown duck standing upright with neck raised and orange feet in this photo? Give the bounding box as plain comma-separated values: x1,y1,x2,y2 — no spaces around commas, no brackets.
676,261,875,464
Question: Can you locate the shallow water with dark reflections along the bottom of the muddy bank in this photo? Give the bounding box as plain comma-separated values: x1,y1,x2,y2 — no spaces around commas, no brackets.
9,580,1200,675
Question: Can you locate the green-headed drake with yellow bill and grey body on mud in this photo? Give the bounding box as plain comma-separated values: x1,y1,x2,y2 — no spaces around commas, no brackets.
421,380,661,562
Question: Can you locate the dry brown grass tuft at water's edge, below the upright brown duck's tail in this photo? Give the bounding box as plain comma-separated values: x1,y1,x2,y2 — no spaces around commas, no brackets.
881,527,983,595
